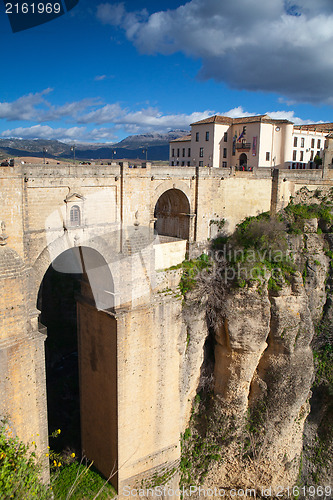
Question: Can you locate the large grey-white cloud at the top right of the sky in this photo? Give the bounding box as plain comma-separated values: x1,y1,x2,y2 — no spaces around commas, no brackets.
97,0,333,104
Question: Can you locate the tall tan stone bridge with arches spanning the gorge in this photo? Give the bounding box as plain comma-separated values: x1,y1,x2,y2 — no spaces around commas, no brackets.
0,163,331,490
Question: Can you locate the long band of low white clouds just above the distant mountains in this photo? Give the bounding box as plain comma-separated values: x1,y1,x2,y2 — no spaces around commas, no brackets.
0,89,324,142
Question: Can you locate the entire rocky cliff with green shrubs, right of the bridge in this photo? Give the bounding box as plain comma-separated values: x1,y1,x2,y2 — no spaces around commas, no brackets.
181,189,333,498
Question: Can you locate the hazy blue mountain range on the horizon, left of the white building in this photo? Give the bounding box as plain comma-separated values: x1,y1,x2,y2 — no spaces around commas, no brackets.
0,130,188,161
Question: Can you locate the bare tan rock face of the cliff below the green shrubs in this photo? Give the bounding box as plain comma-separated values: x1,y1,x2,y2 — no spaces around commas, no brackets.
183,188,333,496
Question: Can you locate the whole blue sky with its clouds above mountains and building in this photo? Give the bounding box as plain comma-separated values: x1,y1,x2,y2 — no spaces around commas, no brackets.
0,0,333,142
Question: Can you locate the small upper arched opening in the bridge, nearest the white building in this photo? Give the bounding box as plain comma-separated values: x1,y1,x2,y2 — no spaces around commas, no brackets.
154,189,190,240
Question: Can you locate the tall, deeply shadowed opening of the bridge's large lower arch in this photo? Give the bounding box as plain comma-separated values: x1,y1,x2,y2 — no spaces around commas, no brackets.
37,247,118,486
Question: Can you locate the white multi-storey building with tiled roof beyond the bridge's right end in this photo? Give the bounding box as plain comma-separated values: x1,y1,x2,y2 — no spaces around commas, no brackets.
170,115,333,170
